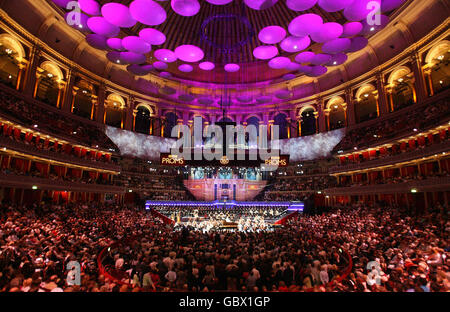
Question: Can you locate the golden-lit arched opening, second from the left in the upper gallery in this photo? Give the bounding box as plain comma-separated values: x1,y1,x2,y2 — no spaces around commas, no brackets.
35,62,64,107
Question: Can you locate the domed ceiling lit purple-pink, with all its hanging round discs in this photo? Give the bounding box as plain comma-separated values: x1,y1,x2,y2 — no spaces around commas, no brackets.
49,0,405,84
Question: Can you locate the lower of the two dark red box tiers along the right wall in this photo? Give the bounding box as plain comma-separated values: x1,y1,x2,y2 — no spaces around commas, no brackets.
325,177,450,195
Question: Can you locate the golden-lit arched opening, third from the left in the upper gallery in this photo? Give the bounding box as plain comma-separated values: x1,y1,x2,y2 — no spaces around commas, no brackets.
72,80,97,119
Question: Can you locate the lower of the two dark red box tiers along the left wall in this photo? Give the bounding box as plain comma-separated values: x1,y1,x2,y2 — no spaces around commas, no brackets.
0,173,125,193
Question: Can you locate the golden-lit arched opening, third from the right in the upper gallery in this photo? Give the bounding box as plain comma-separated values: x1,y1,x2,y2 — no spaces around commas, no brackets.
355,85,378,123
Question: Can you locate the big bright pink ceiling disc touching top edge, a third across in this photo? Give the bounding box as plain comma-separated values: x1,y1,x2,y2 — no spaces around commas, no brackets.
130,0,167,26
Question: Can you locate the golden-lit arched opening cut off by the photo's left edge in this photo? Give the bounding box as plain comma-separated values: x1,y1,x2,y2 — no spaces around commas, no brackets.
0,34,25,88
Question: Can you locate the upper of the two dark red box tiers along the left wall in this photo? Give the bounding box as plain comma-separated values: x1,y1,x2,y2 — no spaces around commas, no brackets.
0,136,120,171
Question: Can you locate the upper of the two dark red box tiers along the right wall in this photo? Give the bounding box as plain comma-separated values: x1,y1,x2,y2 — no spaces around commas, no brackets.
330,141,450,173
